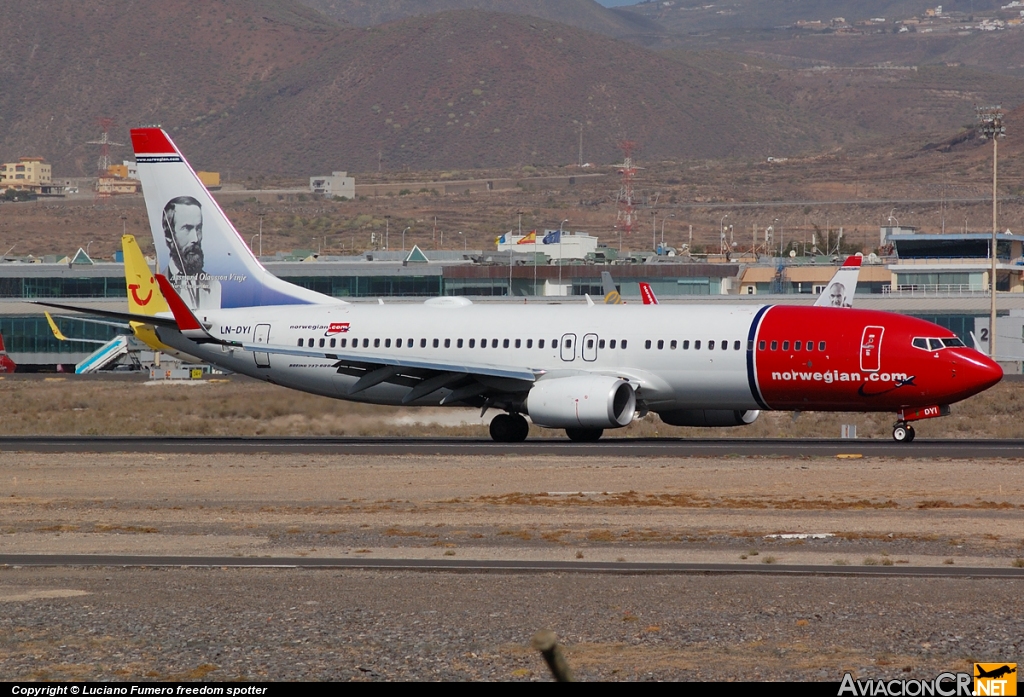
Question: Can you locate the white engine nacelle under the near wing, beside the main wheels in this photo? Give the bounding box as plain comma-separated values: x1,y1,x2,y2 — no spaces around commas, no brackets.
526,376,637,429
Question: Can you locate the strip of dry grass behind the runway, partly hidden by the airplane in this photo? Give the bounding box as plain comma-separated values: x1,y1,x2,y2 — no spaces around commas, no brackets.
0,377,1024,438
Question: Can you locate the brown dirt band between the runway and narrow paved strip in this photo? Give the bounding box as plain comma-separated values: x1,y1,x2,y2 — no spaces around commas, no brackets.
0,452,1024,566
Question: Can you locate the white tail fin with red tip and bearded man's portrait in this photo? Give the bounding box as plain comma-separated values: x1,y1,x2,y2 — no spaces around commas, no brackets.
131,128,340,310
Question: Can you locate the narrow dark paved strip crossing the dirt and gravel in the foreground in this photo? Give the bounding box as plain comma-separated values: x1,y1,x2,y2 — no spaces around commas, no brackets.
0,555,1024,580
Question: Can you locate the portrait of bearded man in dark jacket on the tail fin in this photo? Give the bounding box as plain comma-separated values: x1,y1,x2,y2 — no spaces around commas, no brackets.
163,197,220,310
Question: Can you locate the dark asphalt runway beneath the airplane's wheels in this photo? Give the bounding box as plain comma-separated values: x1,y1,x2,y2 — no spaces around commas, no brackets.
6,436,1024,456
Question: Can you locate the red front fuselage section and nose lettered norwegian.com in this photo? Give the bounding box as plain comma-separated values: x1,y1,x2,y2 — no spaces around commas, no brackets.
754,306,1002,411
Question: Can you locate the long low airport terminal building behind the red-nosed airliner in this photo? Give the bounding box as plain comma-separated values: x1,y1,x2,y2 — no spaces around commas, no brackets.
0,228,1024,371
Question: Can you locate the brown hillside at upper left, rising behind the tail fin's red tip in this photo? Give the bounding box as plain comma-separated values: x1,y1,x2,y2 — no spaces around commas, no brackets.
0,0,341,177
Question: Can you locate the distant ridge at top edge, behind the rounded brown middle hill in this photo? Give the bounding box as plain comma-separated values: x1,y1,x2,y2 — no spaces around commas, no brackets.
302,0,659,37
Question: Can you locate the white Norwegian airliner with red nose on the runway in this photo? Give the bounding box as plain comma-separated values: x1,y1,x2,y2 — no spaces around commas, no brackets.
46,128,1002,442
